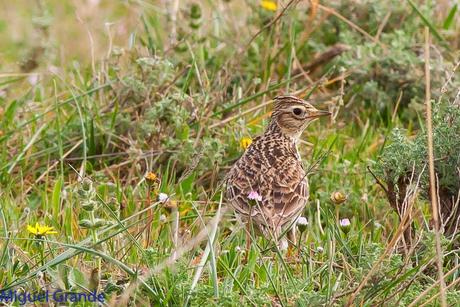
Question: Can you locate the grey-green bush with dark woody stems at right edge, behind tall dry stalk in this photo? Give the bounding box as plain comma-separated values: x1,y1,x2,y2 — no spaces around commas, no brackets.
378,100,460,235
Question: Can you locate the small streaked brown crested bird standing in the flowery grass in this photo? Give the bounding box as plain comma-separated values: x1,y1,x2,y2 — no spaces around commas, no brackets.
226,96,330,249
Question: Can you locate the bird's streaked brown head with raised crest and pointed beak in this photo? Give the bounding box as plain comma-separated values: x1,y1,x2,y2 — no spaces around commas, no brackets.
270,96,331,138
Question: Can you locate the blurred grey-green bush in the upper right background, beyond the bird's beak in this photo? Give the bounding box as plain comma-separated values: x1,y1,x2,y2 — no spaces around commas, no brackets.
325,0,459,119
